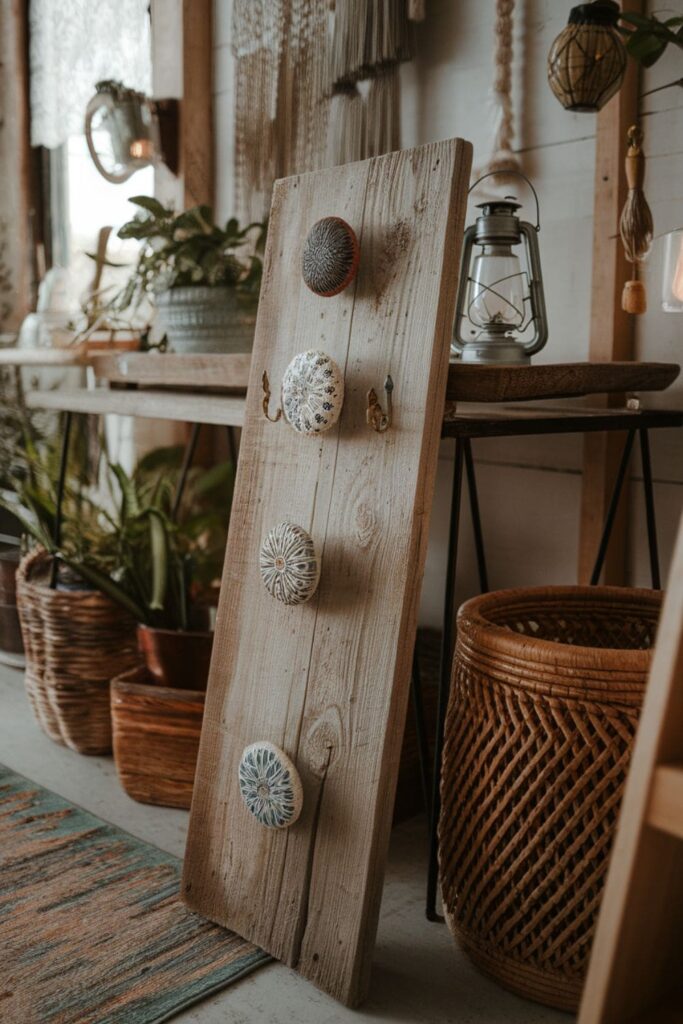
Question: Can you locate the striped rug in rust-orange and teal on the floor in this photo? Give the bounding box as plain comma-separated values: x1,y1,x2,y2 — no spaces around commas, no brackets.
0,766,269,1024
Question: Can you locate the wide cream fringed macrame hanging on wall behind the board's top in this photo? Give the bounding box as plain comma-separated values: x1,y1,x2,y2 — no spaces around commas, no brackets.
232,0,424,220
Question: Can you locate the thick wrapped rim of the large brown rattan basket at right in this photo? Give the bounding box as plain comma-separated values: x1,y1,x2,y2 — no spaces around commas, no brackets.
458,585,664,672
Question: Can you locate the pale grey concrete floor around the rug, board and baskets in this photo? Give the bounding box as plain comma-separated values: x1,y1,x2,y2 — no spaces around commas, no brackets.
0,666,572,1024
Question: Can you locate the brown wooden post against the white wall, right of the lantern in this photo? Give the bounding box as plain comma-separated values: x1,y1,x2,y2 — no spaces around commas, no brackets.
579,0,644,584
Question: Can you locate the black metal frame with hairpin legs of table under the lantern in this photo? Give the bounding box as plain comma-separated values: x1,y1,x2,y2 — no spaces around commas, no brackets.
412,406,683,922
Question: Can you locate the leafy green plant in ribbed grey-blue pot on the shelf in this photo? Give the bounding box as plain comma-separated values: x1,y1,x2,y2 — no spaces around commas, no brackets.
110,196,265,352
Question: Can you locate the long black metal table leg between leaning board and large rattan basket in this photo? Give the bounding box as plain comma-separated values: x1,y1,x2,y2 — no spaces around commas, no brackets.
426,438,465,922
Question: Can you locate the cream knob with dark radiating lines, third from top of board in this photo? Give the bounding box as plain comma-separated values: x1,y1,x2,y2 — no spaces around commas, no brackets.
259,522,321,604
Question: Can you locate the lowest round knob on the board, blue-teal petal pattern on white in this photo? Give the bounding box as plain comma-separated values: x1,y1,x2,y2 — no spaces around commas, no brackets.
240,740,303,828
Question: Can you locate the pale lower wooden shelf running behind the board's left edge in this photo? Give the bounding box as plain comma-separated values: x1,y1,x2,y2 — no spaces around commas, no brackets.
26,387,246,427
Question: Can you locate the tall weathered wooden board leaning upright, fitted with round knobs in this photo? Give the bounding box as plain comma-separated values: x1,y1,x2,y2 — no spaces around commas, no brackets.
183,139,471,1005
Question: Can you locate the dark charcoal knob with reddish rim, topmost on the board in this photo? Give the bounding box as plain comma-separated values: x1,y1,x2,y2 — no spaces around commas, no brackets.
301,217,360,298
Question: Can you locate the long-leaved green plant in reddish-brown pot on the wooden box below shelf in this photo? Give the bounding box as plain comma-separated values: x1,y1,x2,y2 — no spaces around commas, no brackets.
65,447,233,689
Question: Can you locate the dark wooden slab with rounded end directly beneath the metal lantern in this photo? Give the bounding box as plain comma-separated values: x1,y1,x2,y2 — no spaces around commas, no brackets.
446,362,681,401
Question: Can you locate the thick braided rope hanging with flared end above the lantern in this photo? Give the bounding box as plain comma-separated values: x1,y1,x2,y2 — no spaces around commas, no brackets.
475,0,521,182
